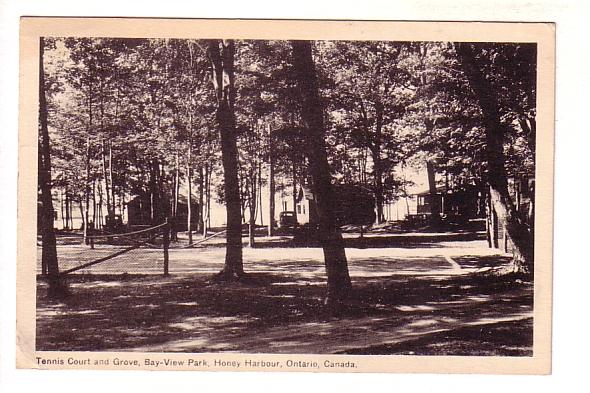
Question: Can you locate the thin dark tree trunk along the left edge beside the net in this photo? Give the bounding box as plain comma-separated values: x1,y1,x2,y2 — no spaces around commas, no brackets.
37,37,68,298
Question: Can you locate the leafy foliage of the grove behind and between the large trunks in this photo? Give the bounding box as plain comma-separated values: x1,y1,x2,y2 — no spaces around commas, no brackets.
45,37,536,230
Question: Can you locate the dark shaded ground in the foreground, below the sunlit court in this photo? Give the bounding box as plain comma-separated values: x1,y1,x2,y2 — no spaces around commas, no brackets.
37,253,532,355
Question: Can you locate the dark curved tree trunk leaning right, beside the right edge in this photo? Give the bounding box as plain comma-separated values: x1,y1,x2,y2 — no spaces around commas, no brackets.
456,43,534,274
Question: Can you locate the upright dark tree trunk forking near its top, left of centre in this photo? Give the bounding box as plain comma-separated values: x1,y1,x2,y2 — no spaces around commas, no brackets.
207,40,244,280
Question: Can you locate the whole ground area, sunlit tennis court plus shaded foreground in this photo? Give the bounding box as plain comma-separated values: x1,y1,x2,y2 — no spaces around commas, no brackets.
37,237,533,356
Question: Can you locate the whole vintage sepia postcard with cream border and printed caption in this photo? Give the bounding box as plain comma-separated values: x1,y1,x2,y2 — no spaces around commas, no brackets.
16,17,555,374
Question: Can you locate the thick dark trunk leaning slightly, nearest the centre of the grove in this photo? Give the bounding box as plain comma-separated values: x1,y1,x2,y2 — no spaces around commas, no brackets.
292,41,352,305
